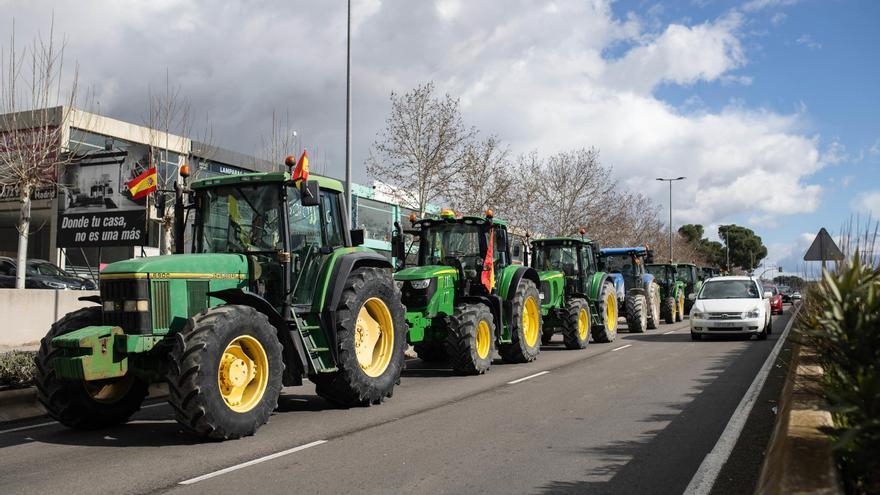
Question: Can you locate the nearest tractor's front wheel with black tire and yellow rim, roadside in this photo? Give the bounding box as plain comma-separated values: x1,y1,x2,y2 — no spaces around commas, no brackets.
167,304,284,440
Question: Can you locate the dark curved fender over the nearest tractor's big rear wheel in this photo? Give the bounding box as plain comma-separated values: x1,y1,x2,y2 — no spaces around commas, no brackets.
313,252,393,362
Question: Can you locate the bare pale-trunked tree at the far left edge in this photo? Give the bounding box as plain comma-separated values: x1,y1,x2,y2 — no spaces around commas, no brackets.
0,17,79,289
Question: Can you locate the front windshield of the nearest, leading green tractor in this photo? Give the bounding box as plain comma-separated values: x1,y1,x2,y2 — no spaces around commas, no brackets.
198,184,282,253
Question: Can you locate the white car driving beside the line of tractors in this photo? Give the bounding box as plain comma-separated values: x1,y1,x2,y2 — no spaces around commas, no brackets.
690,277,773,340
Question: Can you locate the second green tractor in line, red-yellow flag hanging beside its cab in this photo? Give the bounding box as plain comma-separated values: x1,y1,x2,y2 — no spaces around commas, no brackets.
392,210,541,375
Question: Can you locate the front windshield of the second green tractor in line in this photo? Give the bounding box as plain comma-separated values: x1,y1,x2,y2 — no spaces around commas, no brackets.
419,223,484,268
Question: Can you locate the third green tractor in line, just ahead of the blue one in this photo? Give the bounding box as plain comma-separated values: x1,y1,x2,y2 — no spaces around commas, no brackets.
529,232,617,349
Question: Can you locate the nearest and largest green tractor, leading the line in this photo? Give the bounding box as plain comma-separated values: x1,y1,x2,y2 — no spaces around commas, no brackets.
36,168,406,440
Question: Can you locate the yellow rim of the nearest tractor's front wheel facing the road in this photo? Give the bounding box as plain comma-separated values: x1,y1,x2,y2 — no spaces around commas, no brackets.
217,335,269,413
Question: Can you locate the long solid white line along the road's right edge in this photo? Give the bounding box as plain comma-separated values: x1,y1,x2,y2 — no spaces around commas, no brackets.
684,306,801,495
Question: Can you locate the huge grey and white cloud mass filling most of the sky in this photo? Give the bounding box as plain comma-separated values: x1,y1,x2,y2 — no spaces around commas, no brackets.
0,0,823,229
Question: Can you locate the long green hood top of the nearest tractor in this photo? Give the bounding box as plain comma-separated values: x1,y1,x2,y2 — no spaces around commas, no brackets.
101,253,248,278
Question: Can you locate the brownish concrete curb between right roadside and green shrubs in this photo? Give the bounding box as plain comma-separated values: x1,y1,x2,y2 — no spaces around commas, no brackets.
755,324,843,495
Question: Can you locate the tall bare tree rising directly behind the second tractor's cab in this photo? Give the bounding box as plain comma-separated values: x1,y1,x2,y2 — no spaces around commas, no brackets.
367,83,476,217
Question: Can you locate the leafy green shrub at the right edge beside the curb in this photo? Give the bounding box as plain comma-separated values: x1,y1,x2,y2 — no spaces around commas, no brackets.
798,254,880,494
